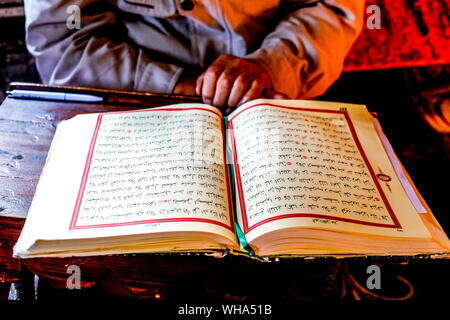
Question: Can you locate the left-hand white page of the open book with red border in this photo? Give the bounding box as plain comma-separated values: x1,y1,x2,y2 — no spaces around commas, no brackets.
22,104,235,241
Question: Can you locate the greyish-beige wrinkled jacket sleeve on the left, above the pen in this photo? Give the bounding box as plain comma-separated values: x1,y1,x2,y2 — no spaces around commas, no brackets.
24,0,182,93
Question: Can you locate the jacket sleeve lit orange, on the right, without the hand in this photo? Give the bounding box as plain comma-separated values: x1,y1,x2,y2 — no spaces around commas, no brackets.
246,0,364,99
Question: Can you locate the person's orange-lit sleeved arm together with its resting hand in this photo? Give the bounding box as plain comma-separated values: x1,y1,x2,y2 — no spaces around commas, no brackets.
196,0,364,108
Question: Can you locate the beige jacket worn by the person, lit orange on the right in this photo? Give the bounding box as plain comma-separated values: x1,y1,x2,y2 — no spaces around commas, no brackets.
25,0,364,98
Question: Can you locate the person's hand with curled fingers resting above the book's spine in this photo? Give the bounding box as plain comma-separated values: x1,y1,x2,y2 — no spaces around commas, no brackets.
195,54,272,113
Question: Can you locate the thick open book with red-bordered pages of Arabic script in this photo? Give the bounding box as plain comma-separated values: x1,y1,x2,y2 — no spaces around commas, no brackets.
14,100,450,258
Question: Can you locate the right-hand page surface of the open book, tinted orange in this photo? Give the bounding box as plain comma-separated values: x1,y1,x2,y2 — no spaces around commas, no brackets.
229,101,429,241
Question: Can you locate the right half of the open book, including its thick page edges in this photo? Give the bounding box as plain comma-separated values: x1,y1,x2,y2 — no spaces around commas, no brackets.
227,101,448,255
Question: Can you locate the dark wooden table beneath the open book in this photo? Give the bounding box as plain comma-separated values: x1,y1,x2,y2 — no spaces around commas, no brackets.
0,84,446,300
